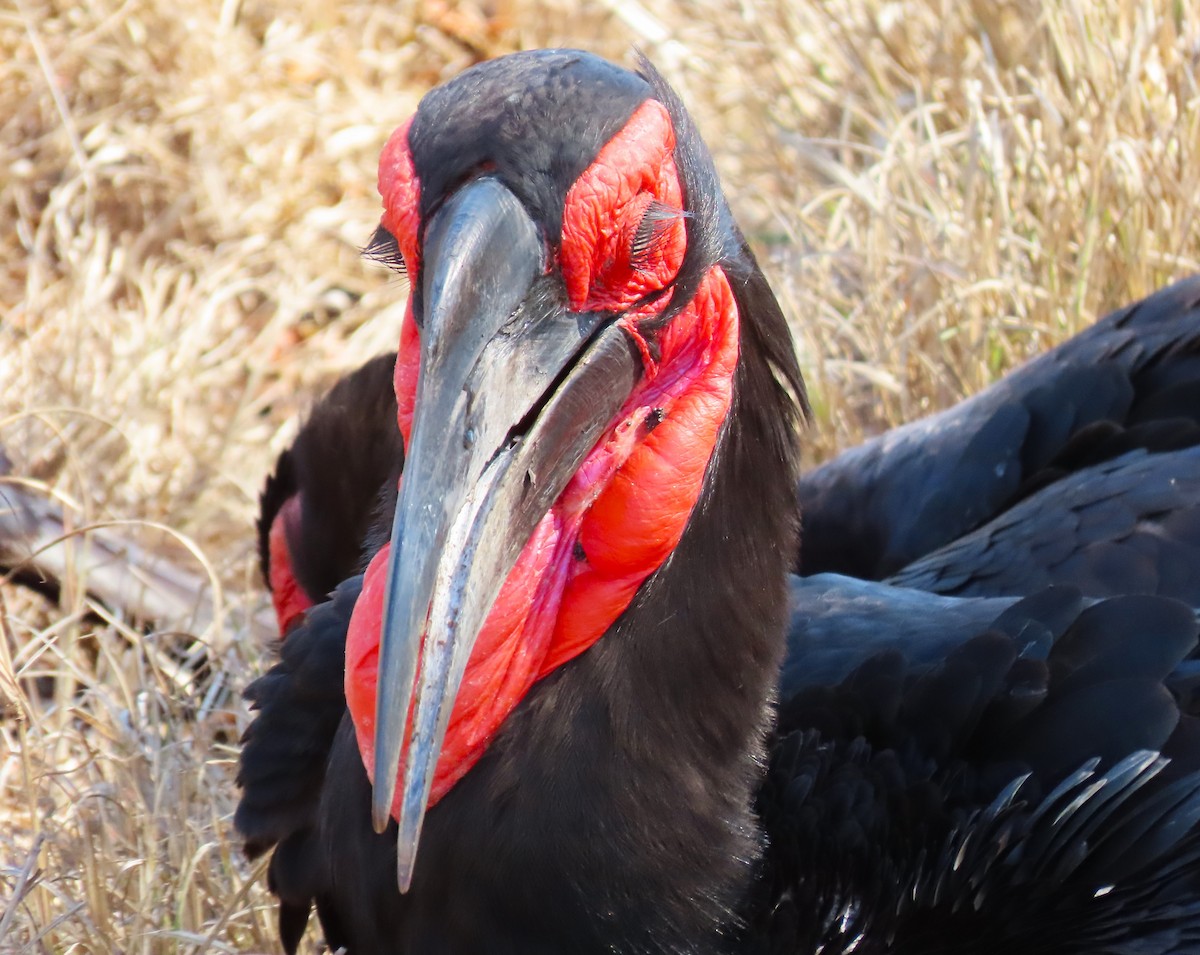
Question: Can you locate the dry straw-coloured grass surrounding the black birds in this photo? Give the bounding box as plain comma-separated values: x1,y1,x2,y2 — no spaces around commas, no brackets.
0,0,1200,953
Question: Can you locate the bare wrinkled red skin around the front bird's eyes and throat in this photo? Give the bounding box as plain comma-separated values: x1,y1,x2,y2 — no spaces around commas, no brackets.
346,100,738,816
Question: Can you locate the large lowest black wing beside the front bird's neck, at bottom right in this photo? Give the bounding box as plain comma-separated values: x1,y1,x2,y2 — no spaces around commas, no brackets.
748,575,1200,955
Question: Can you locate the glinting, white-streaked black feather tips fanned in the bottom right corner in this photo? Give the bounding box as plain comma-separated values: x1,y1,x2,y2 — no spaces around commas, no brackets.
889,752,1200,955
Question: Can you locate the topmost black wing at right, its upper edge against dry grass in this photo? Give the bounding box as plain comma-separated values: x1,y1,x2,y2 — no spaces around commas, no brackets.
798,277,1200,579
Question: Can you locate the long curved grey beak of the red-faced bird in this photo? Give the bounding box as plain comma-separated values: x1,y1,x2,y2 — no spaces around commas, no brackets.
371,178,641,891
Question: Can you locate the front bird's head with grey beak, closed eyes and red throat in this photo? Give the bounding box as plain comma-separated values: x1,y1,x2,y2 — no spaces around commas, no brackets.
346,50,803,891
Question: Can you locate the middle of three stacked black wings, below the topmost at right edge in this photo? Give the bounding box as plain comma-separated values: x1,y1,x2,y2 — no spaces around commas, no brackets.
888,448,1200,607
